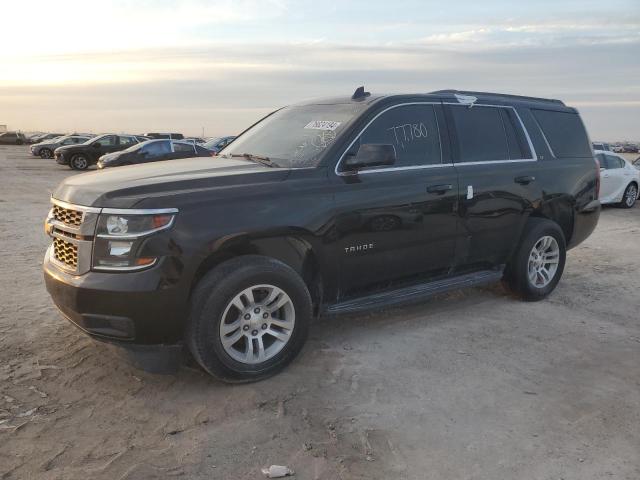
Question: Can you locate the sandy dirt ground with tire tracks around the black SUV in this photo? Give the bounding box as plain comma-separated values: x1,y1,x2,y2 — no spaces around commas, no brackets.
0,146,640,480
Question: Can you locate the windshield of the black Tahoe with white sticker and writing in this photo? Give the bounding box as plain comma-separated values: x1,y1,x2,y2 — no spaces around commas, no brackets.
220,104,366,168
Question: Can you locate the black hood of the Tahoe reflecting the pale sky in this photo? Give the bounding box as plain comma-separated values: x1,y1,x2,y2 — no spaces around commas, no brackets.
53,157,290,208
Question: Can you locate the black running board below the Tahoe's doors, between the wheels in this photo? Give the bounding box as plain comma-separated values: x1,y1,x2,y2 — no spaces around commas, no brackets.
325,269,502,315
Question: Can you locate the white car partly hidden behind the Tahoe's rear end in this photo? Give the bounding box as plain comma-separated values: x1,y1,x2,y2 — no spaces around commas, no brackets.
595,150,640,208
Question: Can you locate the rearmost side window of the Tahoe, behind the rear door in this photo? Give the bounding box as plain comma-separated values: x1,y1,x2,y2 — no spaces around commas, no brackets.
531,109,593,158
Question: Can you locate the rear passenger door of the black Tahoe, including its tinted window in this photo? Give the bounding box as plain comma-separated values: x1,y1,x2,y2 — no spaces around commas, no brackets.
445,104,541,268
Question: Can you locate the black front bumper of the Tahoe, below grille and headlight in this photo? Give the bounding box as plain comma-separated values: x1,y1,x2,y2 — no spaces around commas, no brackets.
43,247,188,346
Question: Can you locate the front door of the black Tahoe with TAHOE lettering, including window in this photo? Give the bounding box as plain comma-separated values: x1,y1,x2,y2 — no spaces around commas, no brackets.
334,103,458,296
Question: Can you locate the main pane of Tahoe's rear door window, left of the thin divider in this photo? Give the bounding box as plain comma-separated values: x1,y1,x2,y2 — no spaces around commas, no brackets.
450,105,510,163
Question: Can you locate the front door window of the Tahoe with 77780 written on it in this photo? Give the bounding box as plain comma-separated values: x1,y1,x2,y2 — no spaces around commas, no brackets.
360,105,441,167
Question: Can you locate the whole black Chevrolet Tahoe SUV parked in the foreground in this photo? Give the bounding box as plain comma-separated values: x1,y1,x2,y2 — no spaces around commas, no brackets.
44,88,600,381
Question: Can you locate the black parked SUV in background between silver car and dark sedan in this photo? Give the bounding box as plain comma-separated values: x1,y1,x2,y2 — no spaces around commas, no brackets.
53,134,140,170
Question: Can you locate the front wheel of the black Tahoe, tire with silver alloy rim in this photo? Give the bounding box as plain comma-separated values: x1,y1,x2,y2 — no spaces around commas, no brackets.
185,255,313,383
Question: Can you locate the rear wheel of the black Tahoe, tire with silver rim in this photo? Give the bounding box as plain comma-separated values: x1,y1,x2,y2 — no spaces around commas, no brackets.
503,218,567,302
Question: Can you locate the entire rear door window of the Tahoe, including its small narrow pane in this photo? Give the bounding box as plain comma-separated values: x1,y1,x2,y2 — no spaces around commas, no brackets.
450,105,532,163
